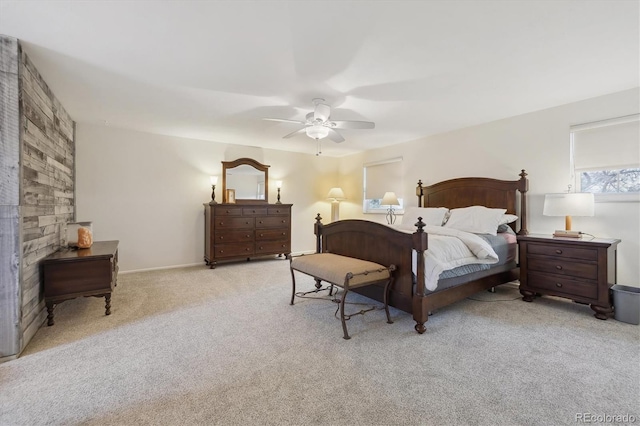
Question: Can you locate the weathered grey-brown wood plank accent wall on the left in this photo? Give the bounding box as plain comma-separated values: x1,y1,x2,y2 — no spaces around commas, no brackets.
0,36,75,360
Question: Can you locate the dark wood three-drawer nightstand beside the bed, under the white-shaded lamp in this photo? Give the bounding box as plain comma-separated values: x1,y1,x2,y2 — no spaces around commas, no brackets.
518,235,620,320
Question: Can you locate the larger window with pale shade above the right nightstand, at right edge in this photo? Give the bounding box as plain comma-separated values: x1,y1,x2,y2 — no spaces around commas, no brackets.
571,114,640,201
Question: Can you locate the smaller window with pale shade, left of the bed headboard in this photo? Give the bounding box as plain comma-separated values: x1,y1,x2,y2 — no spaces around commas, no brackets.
362,157,404,214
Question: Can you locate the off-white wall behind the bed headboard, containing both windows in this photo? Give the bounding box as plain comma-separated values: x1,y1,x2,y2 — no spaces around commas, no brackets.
340,89,640,286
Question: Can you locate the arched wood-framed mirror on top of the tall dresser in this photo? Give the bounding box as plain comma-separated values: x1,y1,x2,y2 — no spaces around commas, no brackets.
222,158,269,204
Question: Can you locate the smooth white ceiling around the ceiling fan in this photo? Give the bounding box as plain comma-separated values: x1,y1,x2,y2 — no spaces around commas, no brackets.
0,0,640,156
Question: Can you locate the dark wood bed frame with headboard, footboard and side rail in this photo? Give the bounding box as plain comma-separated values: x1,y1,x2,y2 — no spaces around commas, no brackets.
314,170,529,334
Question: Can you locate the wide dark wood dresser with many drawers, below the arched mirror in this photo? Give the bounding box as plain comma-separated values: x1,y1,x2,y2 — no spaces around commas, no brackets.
204,203,291,269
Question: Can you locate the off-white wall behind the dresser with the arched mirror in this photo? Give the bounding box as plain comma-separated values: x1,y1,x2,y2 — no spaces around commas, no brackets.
76,124,338,271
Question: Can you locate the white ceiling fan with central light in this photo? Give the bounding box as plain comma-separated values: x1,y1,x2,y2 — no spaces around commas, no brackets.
265,98,375,143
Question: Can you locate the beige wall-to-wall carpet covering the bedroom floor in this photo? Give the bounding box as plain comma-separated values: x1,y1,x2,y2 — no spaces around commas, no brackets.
0,260,640,426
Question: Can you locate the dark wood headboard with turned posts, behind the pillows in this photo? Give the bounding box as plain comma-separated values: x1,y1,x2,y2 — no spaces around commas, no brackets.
416,169,529,235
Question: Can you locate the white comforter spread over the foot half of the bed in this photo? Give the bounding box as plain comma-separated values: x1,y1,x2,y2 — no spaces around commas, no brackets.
396,226,499,291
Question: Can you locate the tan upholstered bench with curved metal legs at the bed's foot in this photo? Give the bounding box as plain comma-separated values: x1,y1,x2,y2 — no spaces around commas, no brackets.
289,253,396,339
